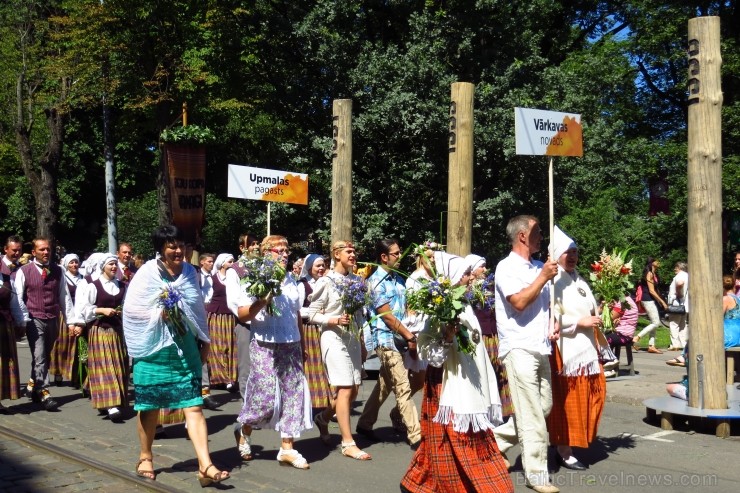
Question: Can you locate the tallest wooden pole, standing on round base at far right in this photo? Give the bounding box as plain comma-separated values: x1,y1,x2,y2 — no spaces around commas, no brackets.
688,17,727,409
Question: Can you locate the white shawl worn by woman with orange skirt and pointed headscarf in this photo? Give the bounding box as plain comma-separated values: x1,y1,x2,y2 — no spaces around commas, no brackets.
555,267,601,377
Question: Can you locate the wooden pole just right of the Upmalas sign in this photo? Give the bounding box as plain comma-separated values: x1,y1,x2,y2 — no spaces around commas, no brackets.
331,99,352,243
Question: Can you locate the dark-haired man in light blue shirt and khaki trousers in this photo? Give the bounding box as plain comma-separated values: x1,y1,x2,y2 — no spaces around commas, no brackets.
357,238,421,450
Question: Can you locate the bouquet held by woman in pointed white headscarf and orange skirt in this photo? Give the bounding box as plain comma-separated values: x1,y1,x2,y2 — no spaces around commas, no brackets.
590,249,634,332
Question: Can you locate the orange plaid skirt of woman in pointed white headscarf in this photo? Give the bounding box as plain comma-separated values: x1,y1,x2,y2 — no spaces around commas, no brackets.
547,344,606,448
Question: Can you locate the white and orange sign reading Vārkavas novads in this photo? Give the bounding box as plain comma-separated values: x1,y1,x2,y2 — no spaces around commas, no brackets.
514,108,583,157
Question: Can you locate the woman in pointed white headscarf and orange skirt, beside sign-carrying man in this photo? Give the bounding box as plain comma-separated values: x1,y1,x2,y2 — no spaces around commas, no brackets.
547,226,606,471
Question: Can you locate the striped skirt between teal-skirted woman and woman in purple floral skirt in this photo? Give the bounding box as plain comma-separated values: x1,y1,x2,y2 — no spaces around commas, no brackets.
208,313,238,385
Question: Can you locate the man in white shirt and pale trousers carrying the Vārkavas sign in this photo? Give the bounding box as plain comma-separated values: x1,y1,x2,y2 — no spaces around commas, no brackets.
494,216,560,493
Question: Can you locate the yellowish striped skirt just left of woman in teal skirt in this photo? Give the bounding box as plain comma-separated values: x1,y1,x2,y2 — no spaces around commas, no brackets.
87,325,128,409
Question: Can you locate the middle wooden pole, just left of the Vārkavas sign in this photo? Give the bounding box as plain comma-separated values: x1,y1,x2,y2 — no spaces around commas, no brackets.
447,82,475,256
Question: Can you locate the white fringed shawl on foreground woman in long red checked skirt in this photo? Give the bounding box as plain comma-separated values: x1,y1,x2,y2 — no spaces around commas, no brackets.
419,306,503,433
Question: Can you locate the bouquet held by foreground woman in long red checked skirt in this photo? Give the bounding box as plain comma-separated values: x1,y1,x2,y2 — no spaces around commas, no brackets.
406,276,475,354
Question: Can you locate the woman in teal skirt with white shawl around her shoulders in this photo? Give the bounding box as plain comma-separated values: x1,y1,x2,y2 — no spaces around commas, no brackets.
123,226,229,486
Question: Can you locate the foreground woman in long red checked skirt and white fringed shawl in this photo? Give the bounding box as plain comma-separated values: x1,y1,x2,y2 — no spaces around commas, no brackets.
401,252,514,493
